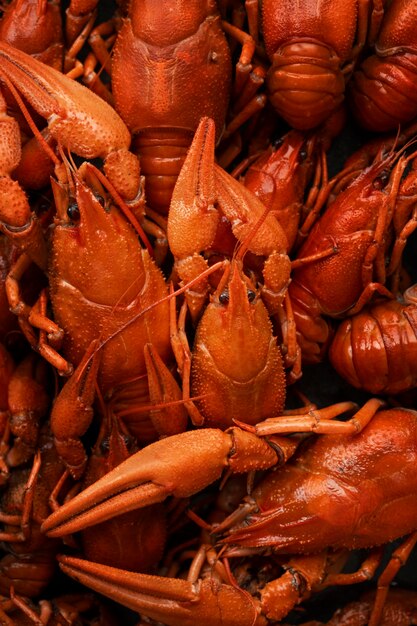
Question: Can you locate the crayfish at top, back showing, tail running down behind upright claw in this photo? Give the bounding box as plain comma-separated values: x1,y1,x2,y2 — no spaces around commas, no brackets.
112,0,232,214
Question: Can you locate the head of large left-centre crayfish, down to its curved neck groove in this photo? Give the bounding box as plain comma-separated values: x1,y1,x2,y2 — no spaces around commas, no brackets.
51,171,145,305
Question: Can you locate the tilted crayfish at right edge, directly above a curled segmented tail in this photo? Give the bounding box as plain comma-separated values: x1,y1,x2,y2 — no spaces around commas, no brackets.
289,136,416,363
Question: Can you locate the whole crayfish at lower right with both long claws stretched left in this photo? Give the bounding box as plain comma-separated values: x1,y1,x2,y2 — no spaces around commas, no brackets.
42,399,417,626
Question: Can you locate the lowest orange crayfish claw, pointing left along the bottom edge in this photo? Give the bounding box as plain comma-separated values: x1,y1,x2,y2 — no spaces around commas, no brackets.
58,556,267,626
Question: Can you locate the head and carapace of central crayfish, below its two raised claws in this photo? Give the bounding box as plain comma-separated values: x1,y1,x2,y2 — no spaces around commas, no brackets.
191,261,285,428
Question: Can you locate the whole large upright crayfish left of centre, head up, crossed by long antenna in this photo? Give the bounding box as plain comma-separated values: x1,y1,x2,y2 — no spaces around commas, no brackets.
38,163,186,476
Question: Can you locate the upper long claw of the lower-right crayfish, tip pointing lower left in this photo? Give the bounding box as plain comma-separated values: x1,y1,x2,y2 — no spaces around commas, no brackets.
42,428,278,537
